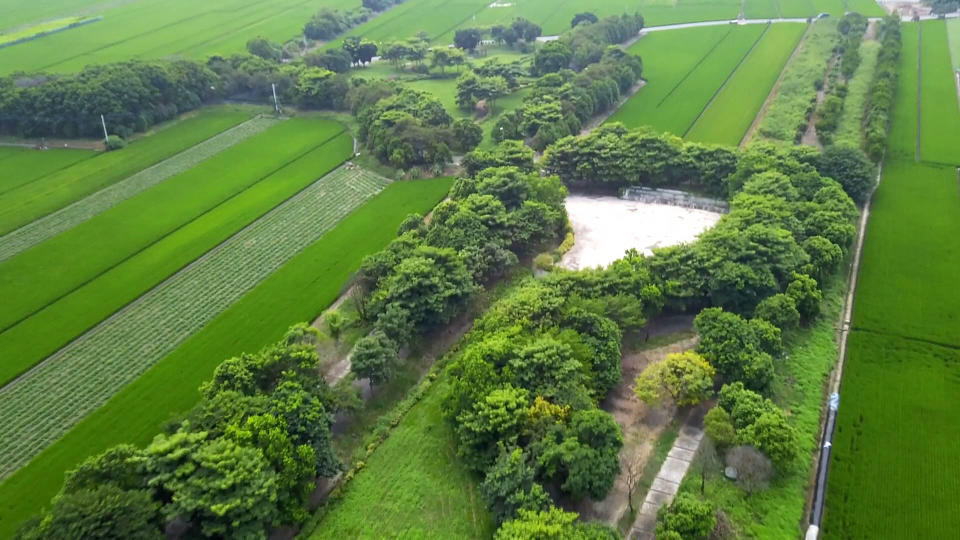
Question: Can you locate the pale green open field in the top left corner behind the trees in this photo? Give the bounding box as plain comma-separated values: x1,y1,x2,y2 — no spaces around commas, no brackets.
0,0,360,74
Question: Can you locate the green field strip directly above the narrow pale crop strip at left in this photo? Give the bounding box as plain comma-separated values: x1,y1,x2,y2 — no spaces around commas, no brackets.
0,106,253,235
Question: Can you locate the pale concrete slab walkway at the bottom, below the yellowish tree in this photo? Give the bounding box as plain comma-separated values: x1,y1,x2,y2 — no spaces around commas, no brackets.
628,422,703,540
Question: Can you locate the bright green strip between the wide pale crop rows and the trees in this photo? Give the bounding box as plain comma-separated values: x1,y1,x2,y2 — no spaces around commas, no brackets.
0,179,452,538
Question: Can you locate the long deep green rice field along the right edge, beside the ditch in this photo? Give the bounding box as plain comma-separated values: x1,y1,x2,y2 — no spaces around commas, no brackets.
824,21,960,538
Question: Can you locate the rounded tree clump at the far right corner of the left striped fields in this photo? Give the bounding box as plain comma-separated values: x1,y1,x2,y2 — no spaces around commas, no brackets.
352,83,483,169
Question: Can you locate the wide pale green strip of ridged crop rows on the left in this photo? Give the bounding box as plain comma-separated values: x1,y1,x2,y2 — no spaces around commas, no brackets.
0,162,387,478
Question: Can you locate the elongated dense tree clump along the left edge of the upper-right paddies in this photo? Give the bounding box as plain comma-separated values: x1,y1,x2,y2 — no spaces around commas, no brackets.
493,48,643,150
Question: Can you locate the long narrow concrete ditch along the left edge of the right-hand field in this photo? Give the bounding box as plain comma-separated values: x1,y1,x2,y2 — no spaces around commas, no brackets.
804,161,883,540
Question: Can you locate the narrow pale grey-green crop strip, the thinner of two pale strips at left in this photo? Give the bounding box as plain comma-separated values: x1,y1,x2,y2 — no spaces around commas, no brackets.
0,115,283,262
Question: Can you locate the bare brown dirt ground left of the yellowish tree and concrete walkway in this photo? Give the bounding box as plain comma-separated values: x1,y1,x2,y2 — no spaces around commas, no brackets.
576,336,697,527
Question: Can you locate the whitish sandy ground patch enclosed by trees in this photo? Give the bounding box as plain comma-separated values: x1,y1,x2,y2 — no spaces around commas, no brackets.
560,195,722,270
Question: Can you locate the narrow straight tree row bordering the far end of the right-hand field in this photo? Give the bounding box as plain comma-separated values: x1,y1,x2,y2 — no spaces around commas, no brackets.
863,15,902,161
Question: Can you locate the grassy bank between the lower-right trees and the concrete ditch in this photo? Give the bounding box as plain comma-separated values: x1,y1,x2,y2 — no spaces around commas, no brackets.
680,260,846,540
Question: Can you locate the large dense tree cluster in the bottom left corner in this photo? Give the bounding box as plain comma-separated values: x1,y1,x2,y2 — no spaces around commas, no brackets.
20,325,341,539
